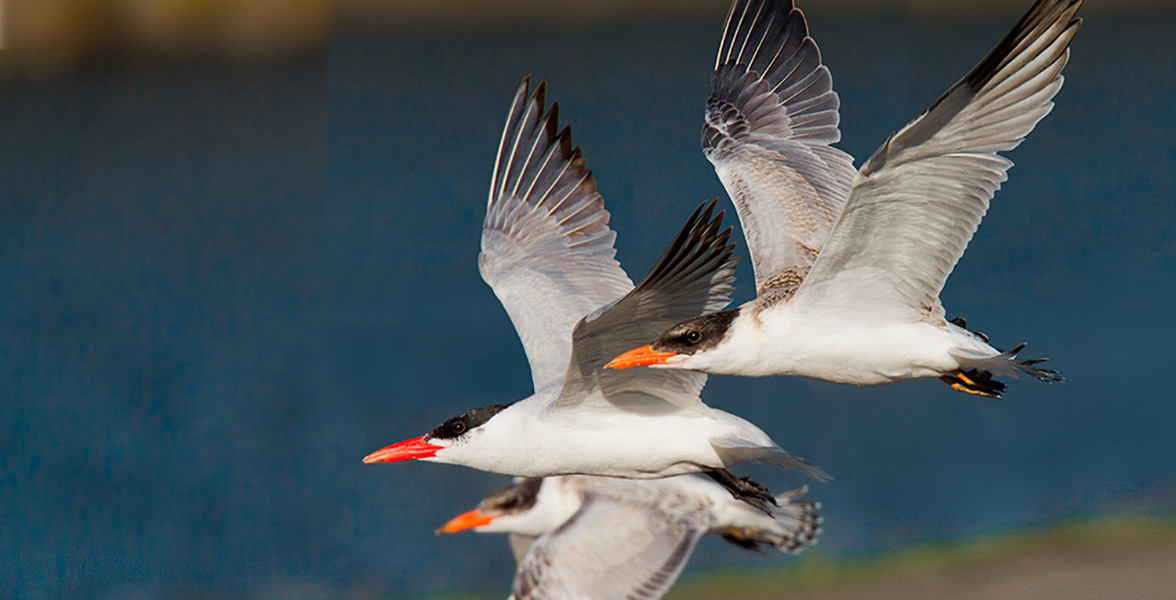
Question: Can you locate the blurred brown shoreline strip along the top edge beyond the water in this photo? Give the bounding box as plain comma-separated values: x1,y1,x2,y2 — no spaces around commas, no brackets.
0,0,1176,74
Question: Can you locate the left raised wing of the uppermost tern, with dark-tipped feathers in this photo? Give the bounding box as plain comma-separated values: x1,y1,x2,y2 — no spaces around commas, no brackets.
702,0,854,295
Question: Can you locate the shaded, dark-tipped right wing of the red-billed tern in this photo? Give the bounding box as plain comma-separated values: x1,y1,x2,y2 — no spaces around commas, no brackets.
556,201,737,411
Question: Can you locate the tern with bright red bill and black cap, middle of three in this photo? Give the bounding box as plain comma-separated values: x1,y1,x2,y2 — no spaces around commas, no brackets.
363,79,826,500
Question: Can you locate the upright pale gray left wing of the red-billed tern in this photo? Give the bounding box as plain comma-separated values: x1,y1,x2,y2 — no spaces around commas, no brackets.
477,78,633,392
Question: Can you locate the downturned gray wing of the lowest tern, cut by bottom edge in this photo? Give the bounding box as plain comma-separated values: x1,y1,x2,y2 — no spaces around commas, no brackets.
512,492,708,600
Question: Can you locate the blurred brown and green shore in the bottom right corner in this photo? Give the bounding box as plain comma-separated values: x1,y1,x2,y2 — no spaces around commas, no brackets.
418,515,1176,600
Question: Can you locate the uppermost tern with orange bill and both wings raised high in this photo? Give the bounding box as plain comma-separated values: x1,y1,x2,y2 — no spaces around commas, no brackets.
608,0,1082,398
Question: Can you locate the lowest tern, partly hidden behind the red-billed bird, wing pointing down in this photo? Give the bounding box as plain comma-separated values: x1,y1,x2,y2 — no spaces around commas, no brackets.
439,475,821,600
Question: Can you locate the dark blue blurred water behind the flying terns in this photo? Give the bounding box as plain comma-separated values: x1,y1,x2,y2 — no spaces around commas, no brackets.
0,11,1176,599
